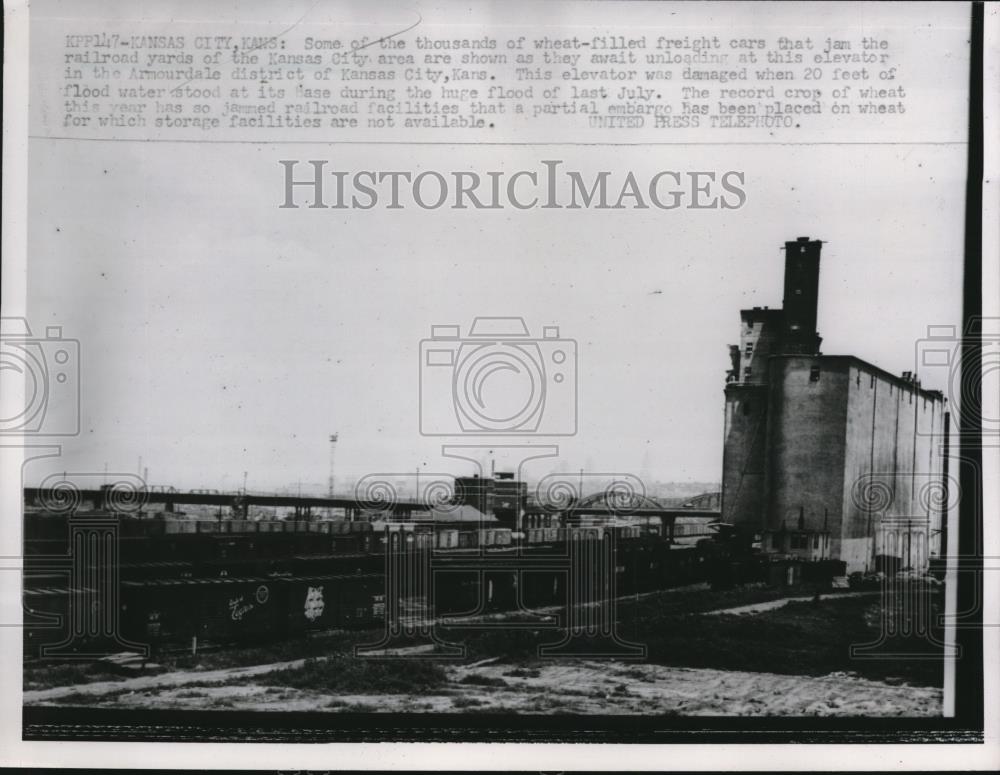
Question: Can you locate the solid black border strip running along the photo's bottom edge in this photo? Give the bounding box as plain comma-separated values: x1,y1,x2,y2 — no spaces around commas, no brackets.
24,707,982,744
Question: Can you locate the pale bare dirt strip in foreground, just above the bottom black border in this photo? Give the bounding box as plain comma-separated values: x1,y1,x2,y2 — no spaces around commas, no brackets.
24,660,942,716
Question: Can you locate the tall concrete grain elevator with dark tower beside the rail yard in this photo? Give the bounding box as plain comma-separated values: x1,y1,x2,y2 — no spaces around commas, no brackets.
722,237,948,572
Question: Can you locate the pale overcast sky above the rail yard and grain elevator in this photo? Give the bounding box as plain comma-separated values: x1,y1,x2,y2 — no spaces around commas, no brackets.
27,135,965,489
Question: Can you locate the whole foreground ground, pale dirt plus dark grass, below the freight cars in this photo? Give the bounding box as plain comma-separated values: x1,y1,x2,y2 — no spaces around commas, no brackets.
24,584,943,716
